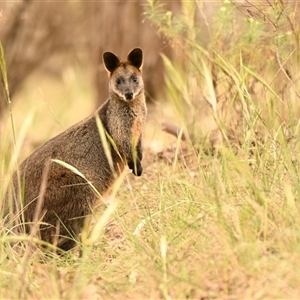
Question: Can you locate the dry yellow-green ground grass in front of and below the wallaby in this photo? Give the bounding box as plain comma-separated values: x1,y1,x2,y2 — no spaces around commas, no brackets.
0,69,300,299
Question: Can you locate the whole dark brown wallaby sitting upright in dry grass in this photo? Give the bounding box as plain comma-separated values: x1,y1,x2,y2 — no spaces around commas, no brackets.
5,48,147,250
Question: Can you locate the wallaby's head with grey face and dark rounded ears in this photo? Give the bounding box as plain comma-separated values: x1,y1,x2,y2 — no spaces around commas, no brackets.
103,48,144,102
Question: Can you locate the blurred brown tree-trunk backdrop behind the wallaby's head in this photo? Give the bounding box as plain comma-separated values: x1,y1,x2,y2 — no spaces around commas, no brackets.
0,0,180,114
